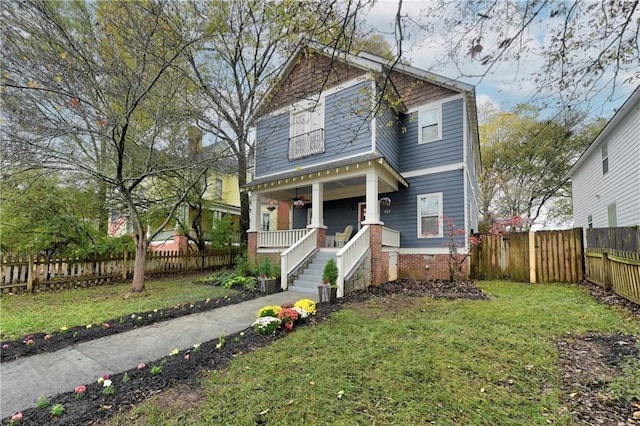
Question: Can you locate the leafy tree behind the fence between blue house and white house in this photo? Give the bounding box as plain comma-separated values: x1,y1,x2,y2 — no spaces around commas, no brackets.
479,106,602,225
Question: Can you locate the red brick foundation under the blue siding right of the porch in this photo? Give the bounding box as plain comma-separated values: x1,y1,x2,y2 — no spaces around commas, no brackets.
398,254,469,280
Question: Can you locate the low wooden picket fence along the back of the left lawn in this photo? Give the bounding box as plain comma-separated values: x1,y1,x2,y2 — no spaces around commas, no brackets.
0,247,240,293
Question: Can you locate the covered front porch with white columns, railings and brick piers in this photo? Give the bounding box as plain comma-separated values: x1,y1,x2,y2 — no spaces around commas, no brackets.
249,158,407,297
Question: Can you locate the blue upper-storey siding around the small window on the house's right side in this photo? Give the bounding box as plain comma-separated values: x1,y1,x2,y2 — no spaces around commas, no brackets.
399,99,464,173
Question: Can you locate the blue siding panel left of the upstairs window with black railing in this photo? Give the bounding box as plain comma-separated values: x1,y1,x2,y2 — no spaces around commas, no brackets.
255,112,291,178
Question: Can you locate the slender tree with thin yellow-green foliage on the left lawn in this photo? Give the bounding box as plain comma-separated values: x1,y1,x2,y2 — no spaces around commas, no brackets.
0,0,214,292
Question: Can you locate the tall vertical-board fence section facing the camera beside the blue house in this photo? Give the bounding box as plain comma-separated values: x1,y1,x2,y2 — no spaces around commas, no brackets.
470,228,584,283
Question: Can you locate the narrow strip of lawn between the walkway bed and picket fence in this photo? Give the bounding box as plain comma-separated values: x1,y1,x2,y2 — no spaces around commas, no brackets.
0,274,235,340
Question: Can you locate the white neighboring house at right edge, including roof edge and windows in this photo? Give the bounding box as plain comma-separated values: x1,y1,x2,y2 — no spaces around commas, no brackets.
569,86,640,229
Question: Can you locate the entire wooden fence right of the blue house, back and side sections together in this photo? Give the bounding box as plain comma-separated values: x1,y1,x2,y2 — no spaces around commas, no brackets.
470,226,640,304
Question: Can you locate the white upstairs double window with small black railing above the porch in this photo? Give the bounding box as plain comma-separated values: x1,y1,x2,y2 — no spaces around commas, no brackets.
289,103,324,160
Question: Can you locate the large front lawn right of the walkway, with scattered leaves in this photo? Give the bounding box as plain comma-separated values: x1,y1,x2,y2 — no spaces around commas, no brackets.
109,281,640,425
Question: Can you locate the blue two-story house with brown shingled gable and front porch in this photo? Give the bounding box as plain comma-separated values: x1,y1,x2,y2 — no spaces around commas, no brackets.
248,48,481,296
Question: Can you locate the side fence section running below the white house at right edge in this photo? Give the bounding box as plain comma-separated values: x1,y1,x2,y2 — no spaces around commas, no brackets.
585,226,640,304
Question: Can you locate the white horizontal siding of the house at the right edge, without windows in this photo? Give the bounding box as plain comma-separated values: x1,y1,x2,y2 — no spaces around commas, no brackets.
571,101,640,228
